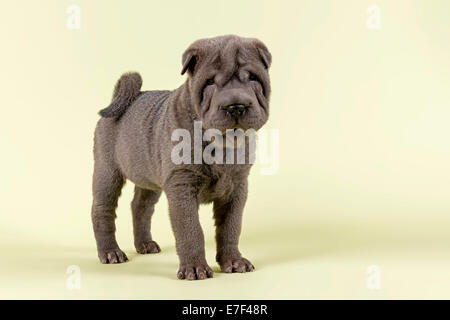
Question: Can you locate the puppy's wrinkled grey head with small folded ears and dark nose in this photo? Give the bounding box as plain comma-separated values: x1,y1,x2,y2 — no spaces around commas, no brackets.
182,36,271,133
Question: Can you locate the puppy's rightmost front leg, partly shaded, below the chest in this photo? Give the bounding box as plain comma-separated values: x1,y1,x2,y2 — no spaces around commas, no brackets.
214,179,255,273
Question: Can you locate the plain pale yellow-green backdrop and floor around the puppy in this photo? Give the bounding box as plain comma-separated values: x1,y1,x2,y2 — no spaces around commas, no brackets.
0,0,450,299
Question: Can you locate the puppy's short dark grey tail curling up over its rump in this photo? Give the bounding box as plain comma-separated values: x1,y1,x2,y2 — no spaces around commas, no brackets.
100,72,142,118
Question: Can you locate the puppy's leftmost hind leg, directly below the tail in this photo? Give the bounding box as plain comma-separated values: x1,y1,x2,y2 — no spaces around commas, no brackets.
92,161,128,263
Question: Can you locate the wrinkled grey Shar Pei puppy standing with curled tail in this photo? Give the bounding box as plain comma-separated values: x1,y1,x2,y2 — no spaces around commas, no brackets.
92,35,271,280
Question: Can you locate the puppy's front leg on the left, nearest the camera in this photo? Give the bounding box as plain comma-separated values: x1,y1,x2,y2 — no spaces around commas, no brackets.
165,172,214,280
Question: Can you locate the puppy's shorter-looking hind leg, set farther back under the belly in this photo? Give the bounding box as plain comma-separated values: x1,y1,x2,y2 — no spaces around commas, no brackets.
131,186,161,254
